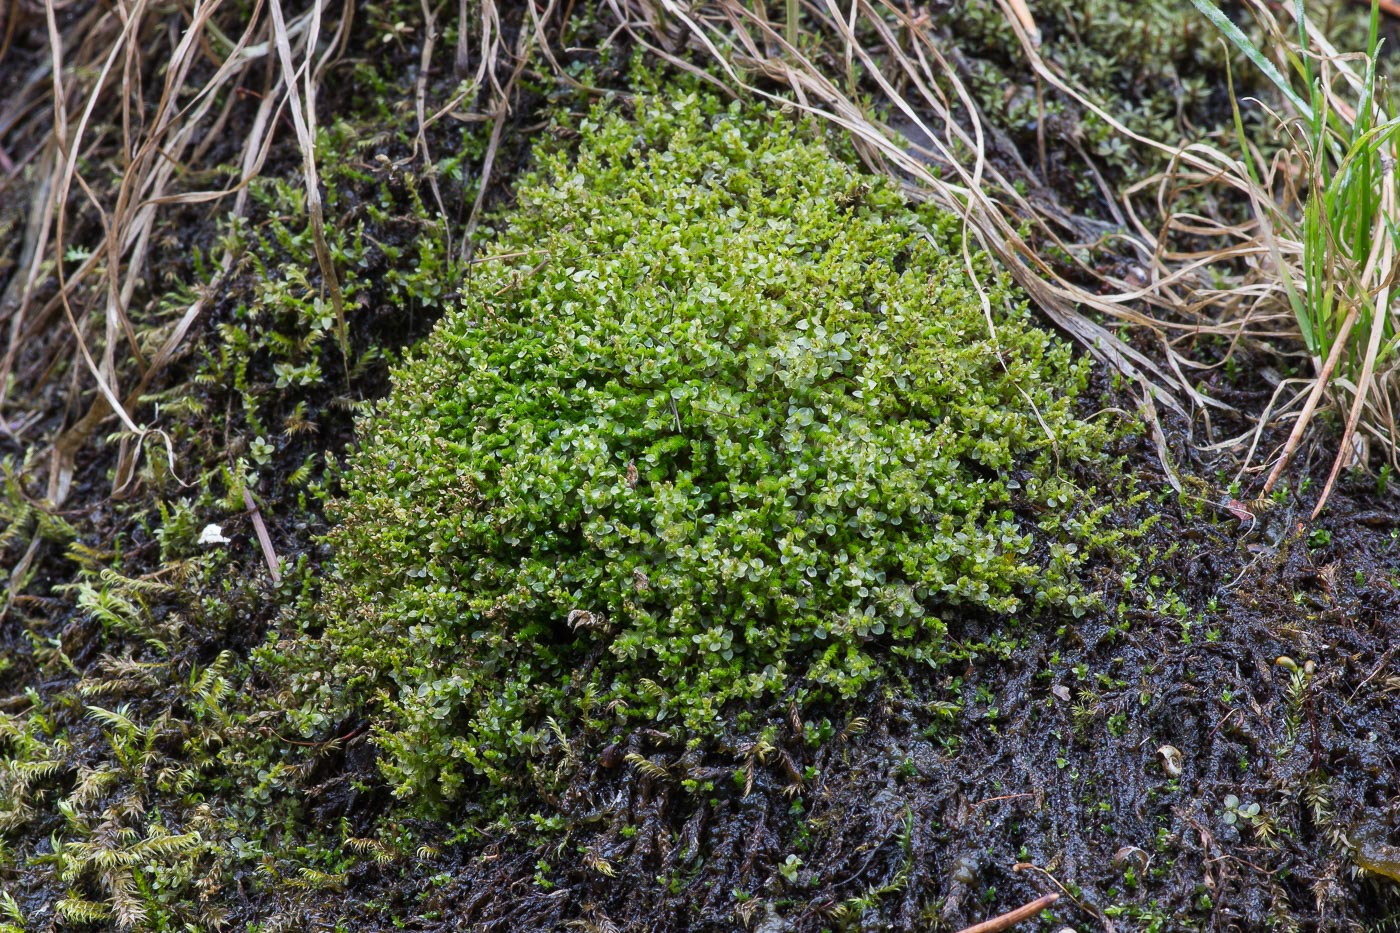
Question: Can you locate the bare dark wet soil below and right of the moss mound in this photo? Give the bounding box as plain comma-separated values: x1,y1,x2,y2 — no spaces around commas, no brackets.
226,395,1400,933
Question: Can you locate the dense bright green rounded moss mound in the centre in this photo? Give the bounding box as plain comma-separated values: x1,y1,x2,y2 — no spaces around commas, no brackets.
304,85,1125,800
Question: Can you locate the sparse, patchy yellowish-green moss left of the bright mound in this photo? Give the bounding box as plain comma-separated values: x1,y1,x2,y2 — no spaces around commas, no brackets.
0,19,504,913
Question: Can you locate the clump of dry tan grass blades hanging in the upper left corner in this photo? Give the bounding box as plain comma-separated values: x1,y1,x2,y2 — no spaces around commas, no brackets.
0,0,334,504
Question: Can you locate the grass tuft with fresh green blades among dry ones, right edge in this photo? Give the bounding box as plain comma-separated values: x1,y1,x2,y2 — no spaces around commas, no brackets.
1191,0,1400,509
